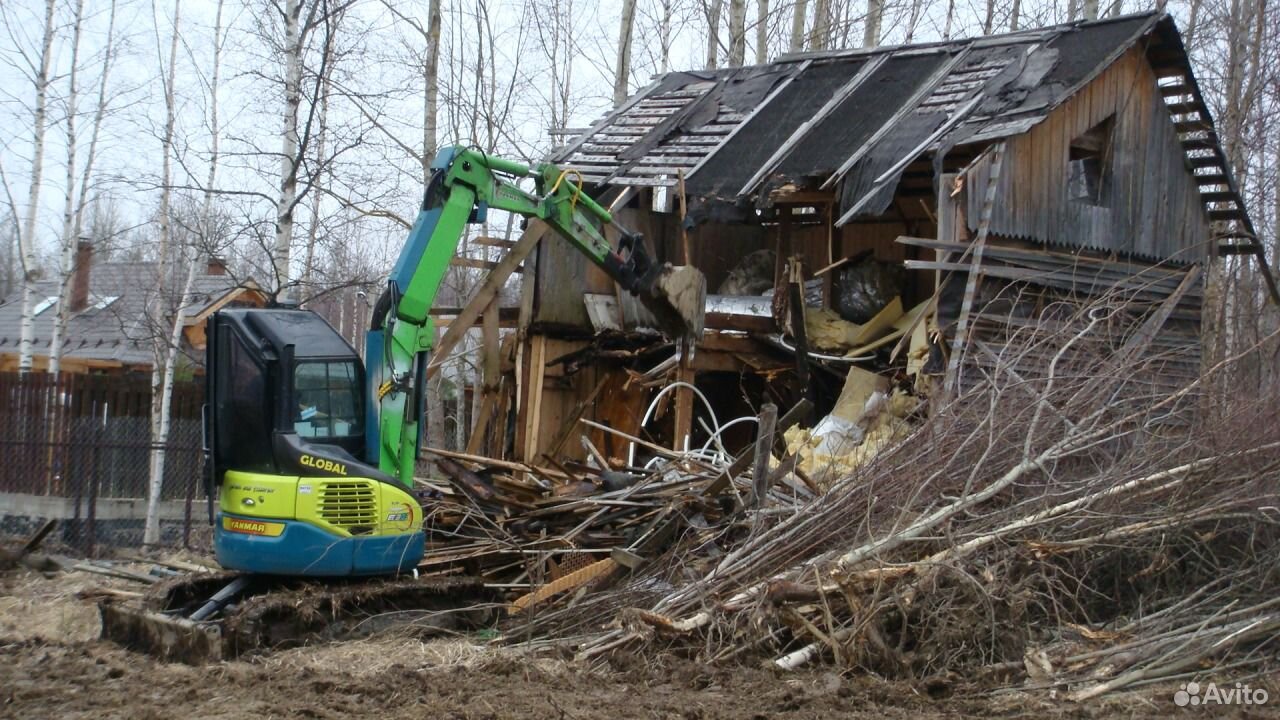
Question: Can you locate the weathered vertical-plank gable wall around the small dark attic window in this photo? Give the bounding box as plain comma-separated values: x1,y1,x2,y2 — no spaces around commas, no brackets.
968,49,1210,263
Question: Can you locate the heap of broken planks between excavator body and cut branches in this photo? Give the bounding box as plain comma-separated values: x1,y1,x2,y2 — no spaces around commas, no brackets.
417,401,817,615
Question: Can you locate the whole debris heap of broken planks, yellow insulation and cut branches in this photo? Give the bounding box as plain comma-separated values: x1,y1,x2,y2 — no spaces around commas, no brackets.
429,289,1280,700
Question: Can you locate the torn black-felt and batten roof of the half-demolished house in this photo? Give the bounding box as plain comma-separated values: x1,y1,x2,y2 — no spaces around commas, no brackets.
553,13,1252,234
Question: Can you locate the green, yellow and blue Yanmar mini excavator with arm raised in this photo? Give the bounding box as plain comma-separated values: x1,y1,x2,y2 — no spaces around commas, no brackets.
100,146,705,660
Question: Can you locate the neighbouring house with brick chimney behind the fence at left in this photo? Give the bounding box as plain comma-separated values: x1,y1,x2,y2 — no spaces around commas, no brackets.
0,242,266,373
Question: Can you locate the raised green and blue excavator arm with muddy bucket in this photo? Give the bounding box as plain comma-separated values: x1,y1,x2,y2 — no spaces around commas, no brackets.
365,146,707,486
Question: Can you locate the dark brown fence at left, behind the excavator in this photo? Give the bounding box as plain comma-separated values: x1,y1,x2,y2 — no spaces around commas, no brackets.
0,373,209,555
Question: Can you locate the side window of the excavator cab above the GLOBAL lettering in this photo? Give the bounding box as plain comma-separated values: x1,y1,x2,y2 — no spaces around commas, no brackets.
293,361,364,438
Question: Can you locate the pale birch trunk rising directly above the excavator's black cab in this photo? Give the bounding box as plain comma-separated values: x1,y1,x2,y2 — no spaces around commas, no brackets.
271,0,302,301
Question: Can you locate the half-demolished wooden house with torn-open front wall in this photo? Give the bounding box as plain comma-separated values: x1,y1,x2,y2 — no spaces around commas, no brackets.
451,13,1265,470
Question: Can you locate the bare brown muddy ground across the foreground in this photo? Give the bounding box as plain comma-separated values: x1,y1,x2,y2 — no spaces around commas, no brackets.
0,563,1280,720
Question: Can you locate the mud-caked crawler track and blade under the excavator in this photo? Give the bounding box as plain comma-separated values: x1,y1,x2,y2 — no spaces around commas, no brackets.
99,573,495,665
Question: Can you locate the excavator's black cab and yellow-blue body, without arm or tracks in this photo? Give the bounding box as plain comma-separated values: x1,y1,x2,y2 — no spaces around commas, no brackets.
205,309,424,577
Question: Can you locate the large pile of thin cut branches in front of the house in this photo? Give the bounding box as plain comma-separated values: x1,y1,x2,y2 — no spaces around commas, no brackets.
509,289,1280,698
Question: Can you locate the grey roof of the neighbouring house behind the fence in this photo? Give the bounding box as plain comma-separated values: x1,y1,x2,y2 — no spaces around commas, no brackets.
0,261,257,365
